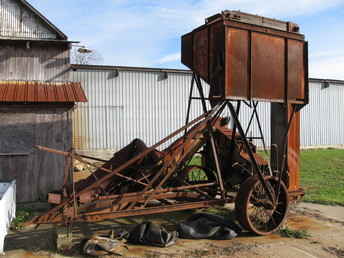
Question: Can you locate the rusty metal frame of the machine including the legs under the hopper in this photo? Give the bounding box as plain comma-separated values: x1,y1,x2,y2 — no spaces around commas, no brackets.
29,71,298,227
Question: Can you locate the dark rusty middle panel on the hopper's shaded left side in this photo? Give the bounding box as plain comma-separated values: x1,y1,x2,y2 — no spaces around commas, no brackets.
193,27,209,81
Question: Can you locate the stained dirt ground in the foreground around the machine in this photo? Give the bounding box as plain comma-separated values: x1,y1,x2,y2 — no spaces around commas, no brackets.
5,203,344,258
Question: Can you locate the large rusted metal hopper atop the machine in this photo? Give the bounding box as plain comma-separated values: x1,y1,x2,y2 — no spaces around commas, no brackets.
182,11,308,104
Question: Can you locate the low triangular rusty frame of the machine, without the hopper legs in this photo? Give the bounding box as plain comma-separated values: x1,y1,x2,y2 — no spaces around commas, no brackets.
30,98,232,224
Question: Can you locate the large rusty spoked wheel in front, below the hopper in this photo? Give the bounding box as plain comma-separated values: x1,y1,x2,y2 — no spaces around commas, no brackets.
235,177,289,235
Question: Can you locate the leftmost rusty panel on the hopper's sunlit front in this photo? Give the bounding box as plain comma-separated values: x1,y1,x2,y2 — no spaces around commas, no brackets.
226,28,251,98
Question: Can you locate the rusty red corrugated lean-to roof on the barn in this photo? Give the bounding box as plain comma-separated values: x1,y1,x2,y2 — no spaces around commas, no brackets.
0,81,87,103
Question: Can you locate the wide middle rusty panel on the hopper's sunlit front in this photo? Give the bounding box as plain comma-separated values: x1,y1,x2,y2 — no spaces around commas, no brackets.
251,32,285,100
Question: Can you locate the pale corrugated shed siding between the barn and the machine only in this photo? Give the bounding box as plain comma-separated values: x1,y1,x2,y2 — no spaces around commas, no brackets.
72,70,207,150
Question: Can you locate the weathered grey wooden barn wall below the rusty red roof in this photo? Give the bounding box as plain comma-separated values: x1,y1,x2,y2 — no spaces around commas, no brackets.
0,107,72,202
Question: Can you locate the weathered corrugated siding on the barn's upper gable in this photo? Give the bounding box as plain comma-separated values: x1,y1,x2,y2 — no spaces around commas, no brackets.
0,0,57,39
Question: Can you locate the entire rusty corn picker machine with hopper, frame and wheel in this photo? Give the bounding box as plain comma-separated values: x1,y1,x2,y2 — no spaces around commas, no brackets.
31,11,308,235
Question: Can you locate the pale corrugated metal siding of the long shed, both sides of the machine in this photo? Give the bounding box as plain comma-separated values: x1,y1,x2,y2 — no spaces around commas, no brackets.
71,69,344,150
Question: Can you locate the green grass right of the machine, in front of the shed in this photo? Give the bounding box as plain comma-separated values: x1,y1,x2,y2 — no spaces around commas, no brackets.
301,149,344,205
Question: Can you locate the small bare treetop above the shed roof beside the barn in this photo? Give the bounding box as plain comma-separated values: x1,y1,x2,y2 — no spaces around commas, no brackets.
71,47,103,64
